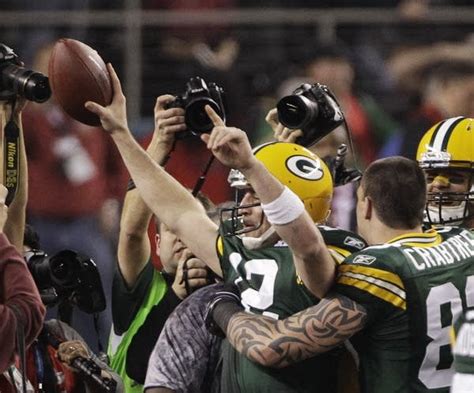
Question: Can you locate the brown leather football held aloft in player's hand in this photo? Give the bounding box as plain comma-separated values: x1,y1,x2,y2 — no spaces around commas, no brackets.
48,38,112,126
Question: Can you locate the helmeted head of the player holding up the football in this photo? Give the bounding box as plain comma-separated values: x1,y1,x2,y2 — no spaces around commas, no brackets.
223,142,333,237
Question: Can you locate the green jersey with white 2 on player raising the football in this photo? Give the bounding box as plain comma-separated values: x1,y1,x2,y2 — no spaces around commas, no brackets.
218,227,366,393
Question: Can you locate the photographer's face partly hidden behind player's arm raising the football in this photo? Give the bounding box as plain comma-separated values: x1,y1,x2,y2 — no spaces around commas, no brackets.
155,193,215,274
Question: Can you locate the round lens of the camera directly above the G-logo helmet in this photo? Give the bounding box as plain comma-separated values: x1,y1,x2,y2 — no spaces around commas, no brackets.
277,95,319,129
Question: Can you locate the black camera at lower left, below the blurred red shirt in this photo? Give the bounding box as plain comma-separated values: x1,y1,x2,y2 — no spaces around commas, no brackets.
25,250,106,314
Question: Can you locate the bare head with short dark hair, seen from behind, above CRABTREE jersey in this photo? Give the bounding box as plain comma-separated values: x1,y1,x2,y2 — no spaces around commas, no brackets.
357,157,426,240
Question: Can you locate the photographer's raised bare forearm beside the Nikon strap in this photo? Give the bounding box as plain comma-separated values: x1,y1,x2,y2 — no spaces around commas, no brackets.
1,97,28,253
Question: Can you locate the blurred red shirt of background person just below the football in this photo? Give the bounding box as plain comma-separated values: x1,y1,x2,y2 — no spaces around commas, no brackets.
23,104,128,218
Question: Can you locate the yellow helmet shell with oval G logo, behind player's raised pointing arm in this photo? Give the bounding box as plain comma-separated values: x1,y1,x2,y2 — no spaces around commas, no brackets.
254,142,333,222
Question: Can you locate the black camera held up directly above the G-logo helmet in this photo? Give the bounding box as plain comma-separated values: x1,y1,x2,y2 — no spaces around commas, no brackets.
277,83,344,147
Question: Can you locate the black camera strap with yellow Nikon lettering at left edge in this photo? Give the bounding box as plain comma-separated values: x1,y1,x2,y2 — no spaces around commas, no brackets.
3,104,20,206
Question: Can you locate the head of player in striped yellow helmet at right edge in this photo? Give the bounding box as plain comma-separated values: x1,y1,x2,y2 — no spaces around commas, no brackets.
416,116,474,225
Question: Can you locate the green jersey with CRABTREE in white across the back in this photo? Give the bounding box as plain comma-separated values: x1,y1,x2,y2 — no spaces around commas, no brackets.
336,227,474,393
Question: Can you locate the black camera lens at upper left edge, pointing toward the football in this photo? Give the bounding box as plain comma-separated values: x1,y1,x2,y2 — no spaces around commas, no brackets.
2,64,51,103
